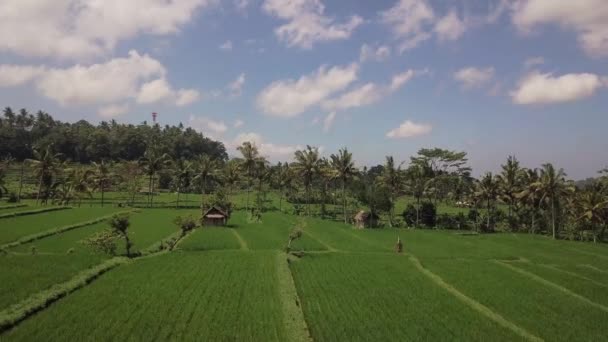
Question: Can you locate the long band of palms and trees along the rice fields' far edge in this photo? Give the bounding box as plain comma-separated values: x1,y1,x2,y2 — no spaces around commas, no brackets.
0,108,608,241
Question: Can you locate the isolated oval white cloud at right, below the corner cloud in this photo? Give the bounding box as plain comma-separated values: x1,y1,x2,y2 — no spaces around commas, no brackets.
511,71,602,104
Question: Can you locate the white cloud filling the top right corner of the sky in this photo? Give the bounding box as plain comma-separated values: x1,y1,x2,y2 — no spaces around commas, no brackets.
512,0,608,57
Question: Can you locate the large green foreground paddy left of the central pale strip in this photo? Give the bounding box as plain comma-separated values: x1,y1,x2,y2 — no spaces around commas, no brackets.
3,251,285,341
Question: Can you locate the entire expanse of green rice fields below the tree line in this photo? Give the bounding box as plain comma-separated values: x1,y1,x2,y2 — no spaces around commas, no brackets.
0,202,608,341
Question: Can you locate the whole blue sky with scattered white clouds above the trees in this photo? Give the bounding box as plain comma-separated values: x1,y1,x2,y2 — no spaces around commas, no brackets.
0,0,608,179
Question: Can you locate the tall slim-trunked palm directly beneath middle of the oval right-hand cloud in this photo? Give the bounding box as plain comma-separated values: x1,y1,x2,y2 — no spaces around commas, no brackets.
536,163,573,239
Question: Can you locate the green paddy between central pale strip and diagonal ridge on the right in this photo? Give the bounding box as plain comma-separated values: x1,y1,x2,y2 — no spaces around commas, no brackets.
292,253,518,341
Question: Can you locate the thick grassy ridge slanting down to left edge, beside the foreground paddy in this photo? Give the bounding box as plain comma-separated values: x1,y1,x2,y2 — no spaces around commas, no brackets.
0,257,129,334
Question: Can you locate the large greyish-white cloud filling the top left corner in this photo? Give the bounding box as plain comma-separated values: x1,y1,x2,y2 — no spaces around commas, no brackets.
0,0,215,59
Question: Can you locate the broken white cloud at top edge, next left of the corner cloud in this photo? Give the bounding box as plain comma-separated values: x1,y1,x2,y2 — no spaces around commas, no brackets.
380,0,467,53
